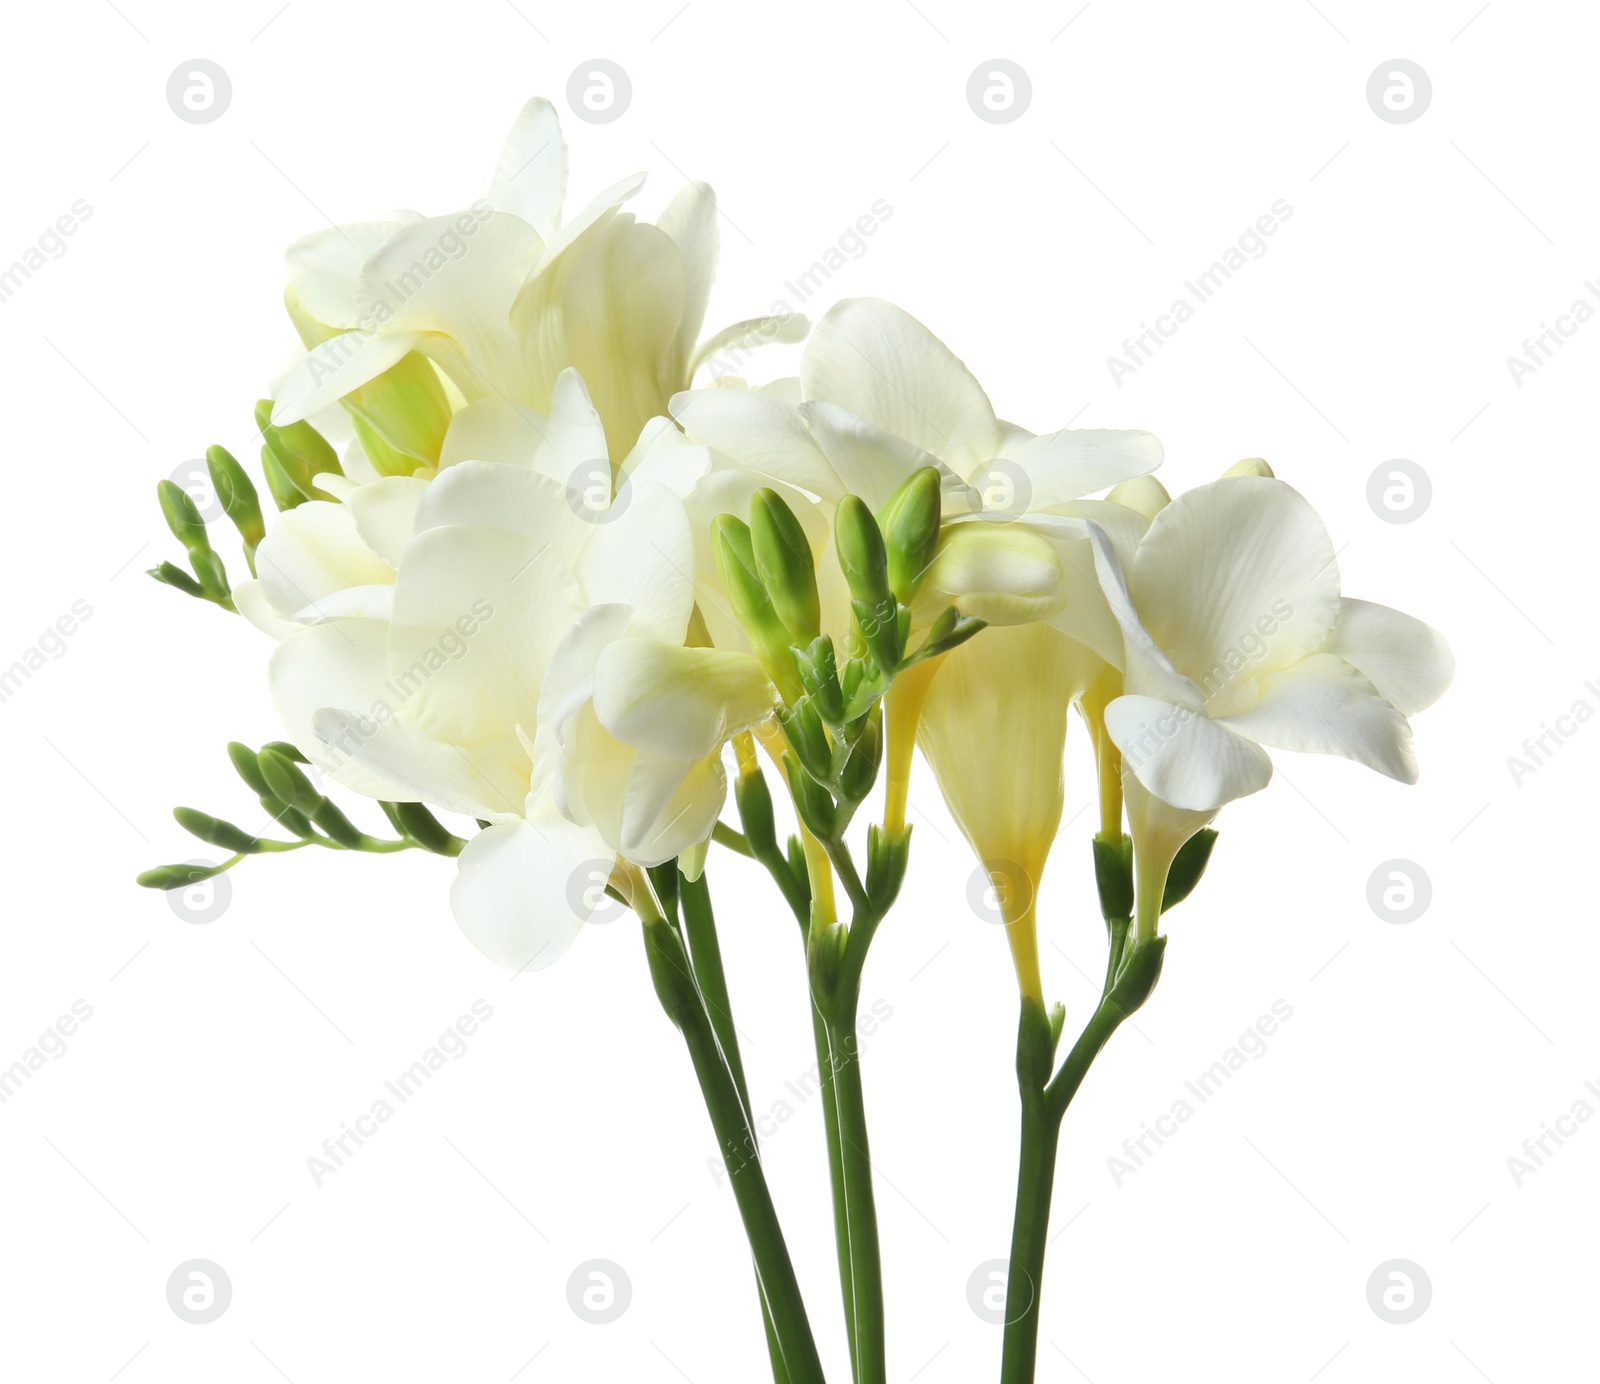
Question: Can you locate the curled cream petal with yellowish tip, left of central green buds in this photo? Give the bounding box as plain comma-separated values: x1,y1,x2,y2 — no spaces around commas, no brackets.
594,638,776,760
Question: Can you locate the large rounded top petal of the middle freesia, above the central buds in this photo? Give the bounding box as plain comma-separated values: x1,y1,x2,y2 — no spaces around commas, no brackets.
800,298,1002,477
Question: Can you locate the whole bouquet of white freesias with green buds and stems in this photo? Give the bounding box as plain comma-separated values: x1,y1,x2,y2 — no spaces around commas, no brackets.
139,101,1453,1384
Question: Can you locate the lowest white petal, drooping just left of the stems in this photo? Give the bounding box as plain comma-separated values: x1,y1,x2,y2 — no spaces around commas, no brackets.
450,813,611,971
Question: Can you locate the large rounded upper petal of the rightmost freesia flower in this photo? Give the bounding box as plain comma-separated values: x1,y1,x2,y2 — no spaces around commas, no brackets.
1128,475,1339,696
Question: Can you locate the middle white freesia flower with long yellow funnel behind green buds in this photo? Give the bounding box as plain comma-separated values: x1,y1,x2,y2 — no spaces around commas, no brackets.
672,298,1165,992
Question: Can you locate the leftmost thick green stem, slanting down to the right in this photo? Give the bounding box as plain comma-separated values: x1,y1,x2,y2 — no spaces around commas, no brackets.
645,922,826,1384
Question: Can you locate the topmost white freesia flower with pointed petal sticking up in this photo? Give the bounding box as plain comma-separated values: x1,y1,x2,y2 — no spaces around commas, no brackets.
272,99,805,461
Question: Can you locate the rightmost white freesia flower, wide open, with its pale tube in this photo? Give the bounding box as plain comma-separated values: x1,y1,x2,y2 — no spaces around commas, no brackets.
1091,469,1454,938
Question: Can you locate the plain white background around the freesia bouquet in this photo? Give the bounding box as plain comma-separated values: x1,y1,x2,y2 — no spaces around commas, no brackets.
0,0,1600,1384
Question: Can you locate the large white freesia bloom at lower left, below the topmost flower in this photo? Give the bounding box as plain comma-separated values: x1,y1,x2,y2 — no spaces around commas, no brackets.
270,371,722,970
